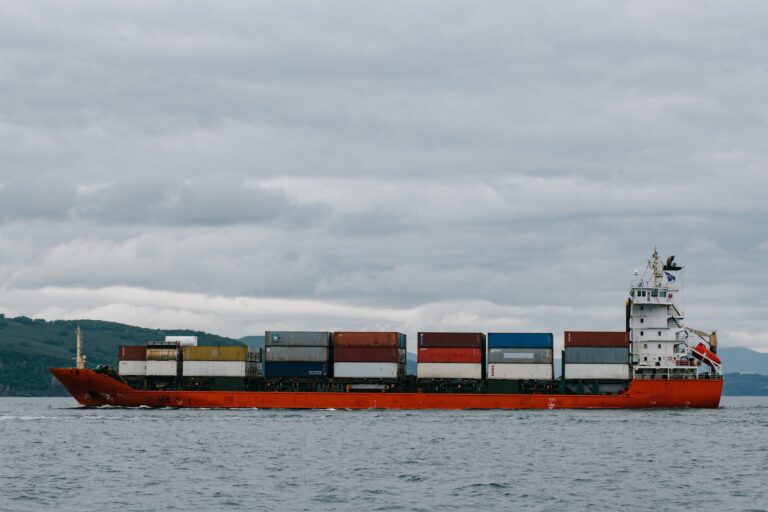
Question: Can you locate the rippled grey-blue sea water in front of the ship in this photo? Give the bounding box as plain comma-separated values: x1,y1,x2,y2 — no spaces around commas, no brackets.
0,397,768,512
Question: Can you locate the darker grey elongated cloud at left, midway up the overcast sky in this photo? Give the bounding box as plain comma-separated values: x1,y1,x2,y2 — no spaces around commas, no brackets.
0,173,328,226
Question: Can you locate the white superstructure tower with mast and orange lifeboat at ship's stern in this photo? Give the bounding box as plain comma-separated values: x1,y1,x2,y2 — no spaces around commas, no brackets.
627,250,721,378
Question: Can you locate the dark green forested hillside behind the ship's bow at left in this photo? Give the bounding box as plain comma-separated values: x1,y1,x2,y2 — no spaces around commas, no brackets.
0,315,242,396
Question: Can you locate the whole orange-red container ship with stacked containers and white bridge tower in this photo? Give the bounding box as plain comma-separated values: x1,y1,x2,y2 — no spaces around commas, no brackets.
50,250,723,409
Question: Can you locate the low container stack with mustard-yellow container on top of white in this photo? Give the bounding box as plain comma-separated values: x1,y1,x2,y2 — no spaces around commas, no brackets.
182,346,261,377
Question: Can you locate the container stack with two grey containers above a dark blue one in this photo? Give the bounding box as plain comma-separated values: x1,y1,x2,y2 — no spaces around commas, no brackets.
264,331,331,377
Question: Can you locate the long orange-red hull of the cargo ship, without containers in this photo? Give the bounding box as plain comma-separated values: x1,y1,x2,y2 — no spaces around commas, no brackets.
50,368,723,409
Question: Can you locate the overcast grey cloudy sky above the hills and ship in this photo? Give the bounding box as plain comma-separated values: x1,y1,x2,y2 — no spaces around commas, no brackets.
0,0,768,351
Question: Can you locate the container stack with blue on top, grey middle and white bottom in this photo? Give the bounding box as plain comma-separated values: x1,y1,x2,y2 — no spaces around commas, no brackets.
487,332,554,380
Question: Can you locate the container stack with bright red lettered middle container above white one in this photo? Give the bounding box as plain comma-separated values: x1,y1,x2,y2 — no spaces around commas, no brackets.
416,332,485,379
